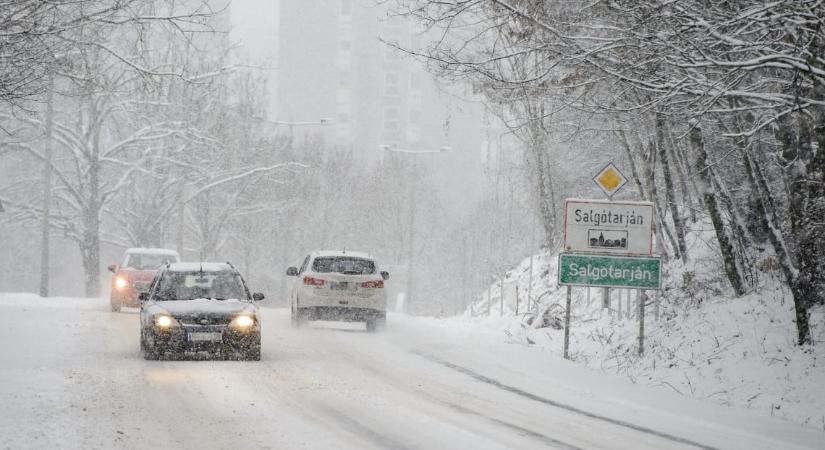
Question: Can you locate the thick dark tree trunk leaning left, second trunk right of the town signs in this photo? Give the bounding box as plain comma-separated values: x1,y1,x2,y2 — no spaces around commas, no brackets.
690,124,745,296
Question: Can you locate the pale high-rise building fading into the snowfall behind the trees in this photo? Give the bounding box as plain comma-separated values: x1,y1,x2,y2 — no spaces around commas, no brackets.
270,0,489,214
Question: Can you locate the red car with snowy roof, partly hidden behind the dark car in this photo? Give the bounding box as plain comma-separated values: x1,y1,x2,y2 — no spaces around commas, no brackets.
109,248,180,312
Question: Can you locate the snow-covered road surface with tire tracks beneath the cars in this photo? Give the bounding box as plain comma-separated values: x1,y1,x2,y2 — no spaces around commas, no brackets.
0,294,825,449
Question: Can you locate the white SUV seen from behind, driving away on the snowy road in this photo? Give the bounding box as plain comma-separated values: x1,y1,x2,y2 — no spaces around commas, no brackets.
286,251,390,331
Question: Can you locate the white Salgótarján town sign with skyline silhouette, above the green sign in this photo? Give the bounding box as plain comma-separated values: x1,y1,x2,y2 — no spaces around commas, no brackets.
564,199,653,256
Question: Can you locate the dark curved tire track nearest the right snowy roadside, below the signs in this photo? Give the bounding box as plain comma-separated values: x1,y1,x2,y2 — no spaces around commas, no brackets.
410,350,718,450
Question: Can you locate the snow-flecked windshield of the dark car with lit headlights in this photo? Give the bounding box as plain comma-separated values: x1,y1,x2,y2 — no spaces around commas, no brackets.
155,271,248,301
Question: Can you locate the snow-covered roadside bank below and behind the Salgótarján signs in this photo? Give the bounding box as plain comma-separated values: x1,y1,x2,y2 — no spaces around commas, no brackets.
459,224,825,430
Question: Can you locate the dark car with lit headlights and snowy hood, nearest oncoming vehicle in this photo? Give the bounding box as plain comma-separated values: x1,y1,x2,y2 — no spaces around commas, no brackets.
140,262,264,361
